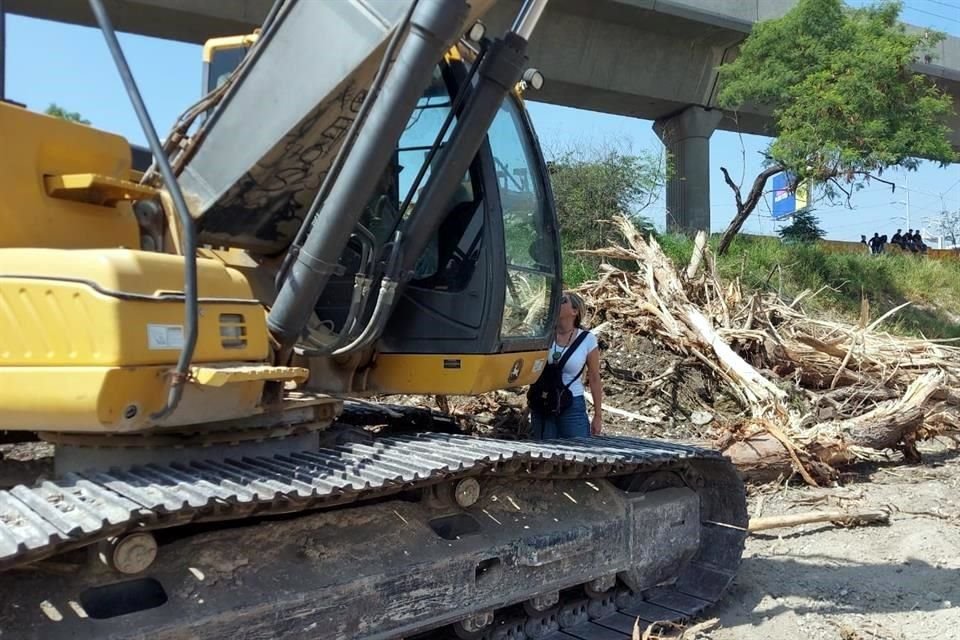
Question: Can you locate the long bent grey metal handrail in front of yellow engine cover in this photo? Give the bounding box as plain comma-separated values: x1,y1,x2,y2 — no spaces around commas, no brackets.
89,0,199,420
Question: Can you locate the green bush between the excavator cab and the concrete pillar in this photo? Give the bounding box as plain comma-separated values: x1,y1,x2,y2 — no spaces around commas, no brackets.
548,145,666,283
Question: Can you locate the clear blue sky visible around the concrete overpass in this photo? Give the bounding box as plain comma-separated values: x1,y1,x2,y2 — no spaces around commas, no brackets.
6,0,960,245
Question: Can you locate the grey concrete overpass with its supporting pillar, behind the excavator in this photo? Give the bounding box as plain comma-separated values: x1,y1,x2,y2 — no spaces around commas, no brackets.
4,0,960,229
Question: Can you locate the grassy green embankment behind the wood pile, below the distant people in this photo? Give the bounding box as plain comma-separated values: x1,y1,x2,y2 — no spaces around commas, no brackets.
660,235,960,338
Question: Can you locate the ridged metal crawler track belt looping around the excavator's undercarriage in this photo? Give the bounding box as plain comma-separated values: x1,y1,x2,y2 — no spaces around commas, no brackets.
0,433,747,640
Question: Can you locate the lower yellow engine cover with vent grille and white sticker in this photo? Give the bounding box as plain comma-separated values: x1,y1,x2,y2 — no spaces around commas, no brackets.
0,249,269,432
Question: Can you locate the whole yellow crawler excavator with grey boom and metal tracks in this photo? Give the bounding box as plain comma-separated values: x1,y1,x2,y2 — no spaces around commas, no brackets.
0,0,747,640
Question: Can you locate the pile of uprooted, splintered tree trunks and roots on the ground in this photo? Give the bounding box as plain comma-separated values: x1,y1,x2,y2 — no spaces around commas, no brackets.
578,217,960,485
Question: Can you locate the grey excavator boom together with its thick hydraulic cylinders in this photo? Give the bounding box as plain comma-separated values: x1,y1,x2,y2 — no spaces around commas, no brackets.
180,0,554,360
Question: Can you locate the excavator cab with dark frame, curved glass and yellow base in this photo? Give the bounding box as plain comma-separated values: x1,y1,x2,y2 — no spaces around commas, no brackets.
326,60,560,393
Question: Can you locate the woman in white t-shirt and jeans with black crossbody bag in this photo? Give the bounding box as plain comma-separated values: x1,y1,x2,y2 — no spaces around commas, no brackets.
528,293,603,440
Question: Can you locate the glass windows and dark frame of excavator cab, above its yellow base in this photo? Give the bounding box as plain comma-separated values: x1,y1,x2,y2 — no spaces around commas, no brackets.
372,61,559,353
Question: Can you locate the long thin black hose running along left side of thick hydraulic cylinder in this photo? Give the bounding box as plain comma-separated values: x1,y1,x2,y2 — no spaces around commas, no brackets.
275,0,419,289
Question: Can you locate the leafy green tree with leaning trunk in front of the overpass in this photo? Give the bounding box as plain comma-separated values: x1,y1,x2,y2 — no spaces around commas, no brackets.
718,0,956,254
